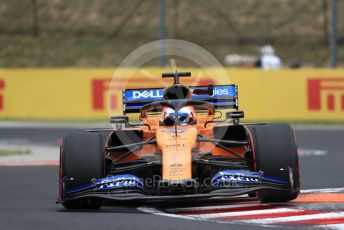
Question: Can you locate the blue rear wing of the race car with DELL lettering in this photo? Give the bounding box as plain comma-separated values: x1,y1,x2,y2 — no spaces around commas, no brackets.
122,84,239,114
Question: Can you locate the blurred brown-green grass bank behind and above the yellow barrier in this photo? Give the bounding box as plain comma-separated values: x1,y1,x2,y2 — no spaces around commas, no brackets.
0,0,344,67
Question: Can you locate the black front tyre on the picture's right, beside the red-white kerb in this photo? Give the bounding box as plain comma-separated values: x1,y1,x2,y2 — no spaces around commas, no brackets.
247,124,300,203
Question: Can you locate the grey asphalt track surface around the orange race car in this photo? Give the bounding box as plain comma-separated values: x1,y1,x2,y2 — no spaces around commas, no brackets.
0,128,344,230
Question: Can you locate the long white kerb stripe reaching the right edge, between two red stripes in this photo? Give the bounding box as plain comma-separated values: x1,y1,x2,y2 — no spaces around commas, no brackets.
242,212,344,224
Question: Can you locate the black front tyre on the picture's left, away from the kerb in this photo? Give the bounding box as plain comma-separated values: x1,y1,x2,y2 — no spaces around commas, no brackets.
60,131,105,209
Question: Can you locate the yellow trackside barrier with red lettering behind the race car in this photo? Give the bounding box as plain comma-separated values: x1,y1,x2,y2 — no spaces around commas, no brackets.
0,68,344,121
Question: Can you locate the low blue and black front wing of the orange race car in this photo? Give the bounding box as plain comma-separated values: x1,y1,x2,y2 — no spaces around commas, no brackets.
58,170,291,203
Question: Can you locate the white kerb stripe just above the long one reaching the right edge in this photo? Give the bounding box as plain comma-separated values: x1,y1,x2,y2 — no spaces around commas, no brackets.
186,208,296,219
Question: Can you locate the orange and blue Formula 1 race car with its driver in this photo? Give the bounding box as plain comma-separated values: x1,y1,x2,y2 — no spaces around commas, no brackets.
58,72,300,209
